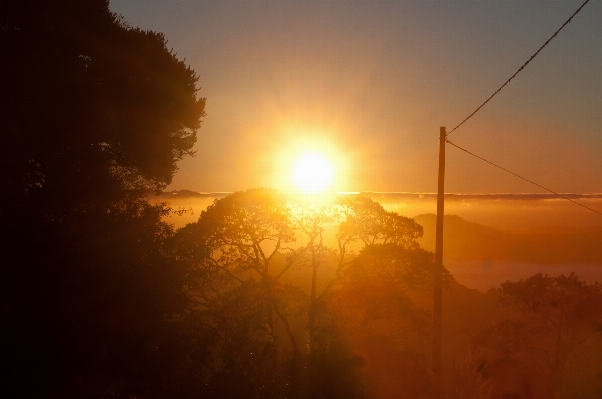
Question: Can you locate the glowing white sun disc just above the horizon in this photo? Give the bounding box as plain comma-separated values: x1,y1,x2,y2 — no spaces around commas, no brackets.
292,152,334,193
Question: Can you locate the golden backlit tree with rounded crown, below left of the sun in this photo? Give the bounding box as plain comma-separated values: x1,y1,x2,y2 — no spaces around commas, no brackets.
185,189,299,353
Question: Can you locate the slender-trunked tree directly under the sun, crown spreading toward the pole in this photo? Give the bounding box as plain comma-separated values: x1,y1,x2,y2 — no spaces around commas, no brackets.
288,196,422,354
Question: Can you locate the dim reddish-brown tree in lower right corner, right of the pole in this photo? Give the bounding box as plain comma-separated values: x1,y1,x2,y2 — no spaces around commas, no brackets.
462,273,602,398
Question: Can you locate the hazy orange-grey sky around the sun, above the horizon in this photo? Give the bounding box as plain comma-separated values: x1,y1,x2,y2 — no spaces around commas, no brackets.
111,0,602,193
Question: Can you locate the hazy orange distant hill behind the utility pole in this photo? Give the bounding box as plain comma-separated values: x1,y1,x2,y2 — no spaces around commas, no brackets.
414,214,602,266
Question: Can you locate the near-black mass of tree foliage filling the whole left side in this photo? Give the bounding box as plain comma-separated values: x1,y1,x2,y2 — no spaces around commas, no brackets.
0,0,205,398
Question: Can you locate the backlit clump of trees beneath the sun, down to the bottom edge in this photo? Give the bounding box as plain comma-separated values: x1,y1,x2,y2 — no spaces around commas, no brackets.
169,192,433,398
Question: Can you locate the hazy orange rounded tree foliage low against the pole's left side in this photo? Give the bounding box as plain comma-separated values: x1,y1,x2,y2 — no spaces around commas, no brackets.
334,244,434,350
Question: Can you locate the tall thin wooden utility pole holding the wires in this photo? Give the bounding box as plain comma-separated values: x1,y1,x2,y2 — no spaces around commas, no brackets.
433,127,447,397
